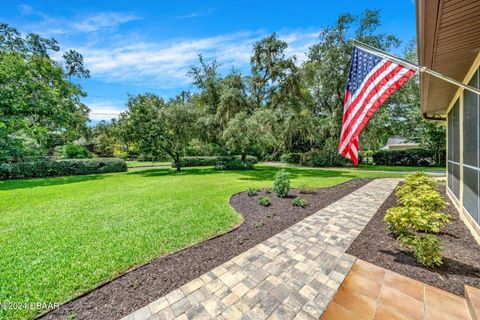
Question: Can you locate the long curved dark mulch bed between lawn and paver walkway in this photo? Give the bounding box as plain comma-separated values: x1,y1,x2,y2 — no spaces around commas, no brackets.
41,179,369,320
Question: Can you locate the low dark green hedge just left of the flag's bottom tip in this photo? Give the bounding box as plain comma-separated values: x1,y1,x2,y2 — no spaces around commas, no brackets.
280,150,348,167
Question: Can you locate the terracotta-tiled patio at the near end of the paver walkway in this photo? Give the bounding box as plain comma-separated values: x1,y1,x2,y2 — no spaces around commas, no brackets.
321,259,479,320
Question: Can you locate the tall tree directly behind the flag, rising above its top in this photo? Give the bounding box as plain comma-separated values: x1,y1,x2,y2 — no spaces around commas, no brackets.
302,10,400,158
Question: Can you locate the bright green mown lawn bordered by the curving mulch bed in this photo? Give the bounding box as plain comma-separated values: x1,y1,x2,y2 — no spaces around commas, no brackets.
0,165,404,319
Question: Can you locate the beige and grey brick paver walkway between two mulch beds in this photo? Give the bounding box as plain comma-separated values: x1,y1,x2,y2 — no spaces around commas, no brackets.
124,179,399,320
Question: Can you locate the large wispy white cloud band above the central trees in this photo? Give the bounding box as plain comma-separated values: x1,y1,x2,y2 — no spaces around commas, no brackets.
76,31,318,89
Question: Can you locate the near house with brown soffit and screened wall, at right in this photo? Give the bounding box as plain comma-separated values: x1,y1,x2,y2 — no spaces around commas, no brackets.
417,0,480,239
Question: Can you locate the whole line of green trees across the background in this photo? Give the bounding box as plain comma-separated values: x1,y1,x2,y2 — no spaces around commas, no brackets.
0,10,445,170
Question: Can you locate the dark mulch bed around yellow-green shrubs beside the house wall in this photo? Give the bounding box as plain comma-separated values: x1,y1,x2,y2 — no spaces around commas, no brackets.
347,187,480,296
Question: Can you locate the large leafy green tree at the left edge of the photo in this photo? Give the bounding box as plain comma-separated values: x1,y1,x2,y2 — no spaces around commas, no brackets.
0,24,89,161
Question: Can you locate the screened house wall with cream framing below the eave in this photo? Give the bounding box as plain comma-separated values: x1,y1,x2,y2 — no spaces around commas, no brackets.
447,54,480,243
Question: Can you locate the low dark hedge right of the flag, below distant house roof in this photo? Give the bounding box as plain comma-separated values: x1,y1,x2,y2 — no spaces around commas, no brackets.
372,148,444,166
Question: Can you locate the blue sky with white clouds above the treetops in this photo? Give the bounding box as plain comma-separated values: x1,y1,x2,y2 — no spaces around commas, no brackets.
0,0,415,123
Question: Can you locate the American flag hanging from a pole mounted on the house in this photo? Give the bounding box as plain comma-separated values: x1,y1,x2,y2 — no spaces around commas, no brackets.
338,46,415,166
